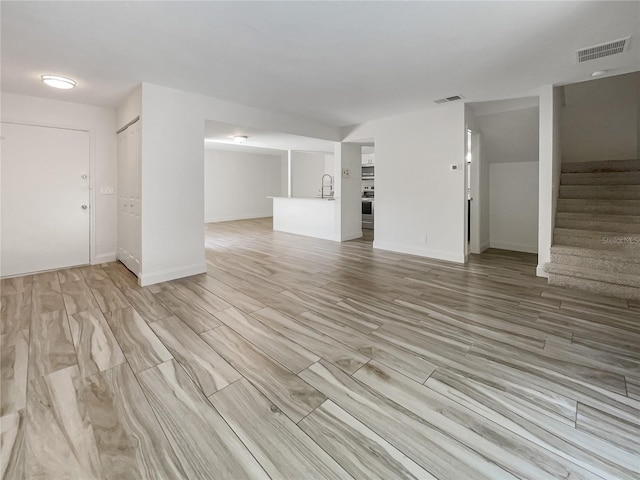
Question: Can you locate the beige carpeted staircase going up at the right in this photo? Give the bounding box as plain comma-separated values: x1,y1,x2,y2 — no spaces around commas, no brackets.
545,160,640,300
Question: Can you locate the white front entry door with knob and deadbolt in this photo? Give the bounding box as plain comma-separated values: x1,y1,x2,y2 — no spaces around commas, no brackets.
0,122,91,277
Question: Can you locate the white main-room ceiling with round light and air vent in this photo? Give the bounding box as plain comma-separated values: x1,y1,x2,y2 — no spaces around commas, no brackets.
0,0,640,126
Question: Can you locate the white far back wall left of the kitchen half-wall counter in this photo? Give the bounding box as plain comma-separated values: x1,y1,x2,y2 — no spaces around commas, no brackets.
204,149,282,223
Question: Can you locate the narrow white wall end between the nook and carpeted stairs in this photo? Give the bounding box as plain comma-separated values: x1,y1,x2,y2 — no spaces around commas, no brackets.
536,85,564,277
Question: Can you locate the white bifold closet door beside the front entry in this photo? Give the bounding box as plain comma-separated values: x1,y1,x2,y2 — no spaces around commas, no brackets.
118,121,141,275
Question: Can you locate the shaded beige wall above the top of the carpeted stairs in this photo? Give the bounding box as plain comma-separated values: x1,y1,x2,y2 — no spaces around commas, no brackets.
562,72,640,162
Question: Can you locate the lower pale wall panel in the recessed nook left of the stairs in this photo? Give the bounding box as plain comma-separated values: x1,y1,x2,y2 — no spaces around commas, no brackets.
489,162,538,253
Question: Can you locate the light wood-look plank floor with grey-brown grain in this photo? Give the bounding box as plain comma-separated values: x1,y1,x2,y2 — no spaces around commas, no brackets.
0,219,640,480
